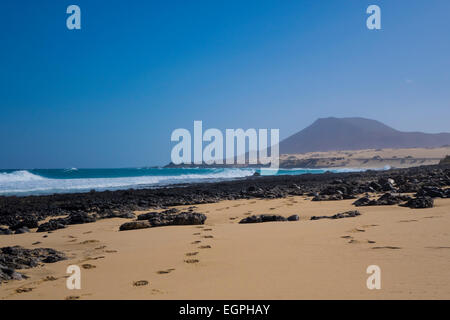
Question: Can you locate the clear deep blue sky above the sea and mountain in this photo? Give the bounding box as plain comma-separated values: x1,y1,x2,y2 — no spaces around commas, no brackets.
0,0,450,168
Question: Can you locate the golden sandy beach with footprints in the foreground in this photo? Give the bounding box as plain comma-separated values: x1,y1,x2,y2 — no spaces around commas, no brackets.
0,192,450,300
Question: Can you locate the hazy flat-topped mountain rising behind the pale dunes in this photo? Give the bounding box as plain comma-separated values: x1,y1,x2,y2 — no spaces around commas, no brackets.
280,118,450,154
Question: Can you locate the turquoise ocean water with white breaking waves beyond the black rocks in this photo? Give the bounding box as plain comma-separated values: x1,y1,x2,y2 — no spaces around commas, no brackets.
0,168,364,196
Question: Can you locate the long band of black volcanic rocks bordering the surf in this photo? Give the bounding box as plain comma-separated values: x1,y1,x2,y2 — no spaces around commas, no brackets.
0,165,450,226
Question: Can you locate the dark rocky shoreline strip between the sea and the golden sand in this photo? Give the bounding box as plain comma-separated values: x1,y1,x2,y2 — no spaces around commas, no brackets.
0,166,450,234
